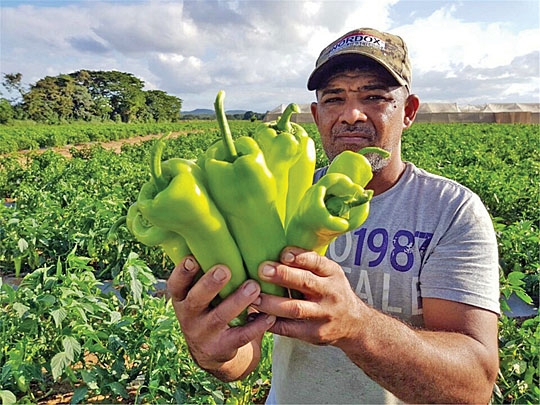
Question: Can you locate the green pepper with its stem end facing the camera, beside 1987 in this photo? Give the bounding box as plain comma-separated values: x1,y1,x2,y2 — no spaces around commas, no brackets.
287,173,373,255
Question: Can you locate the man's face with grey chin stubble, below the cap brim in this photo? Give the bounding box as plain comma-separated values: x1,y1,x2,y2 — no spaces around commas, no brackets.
312,69,408,166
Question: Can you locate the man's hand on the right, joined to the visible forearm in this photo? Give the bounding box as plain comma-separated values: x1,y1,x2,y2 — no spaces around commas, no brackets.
249,243,362,345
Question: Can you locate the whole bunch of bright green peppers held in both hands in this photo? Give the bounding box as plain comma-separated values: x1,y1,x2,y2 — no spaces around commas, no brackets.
126,91,388,322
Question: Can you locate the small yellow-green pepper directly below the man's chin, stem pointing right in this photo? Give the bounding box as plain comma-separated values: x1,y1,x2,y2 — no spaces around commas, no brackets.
327,146,390,187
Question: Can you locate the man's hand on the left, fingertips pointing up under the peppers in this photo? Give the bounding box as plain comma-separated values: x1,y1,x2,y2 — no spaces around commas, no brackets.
167,256,275,381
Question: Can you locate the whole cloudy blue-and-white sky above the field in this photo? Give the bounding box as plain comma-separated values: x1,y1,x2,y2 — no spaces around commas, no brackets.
0,0,540,112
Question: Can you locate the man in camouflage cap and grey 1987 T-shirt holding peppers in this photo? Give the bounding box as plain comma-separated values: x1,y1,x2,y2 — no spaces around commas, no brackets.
168,28,499,404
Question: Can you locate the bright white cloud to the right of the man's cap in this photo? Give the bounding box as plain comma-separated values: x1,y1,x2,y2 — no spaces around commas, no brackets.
399,5,540,103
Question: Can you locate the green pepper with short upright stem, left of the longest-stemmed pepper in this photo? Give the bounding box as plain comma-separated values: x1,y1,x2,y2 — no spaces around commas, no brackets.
137,135,247,298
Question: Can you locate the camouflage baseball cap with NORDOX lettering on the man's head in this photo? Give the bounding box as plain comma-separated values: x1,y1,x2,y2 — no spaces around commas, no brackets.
307,28,412,90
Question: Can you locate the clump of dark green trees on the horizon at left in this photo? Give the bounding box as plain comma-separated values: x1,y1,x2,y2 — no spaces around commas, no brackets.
0,70,186,124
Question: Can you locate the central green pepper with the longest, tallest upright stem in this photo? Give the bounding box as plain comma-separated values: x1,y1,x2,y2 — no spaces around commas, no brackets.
199,91,286,296
